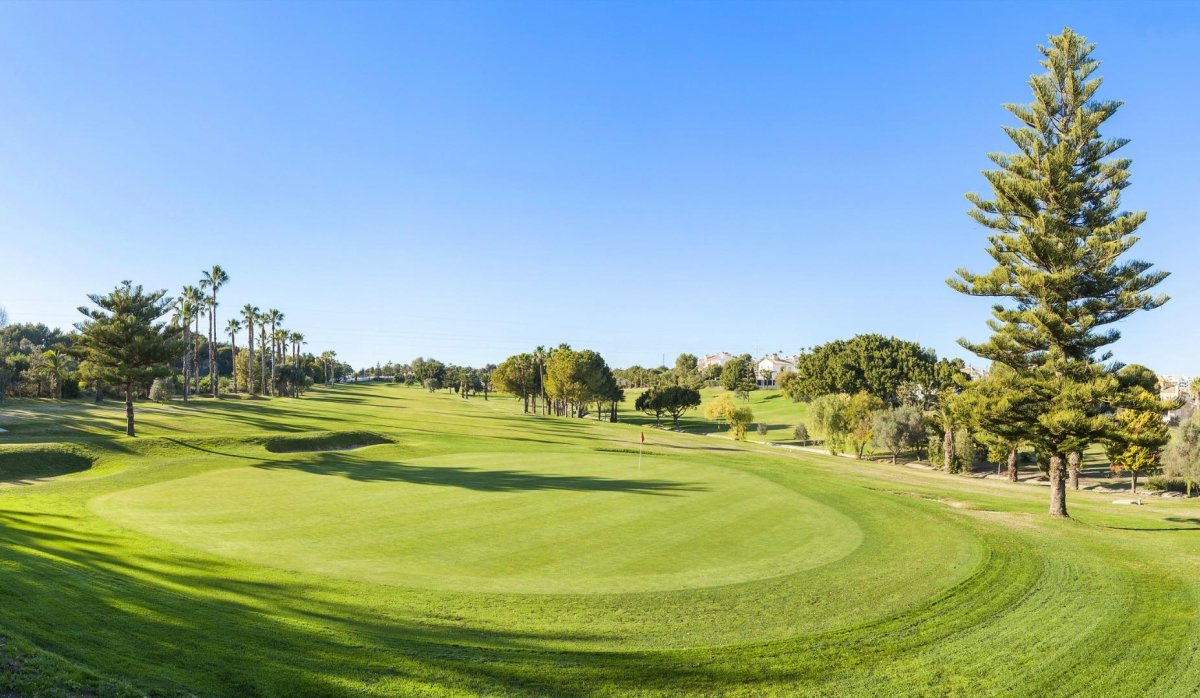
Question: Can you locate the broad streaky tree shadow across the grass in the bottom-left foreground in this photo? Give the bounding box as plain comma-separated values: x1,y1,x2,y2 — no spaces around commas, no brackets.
0,510,748,697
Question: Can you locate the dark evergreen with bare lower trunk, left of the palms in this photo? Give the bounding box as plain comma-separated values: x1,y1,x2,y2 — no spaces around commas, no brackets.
74,281,184,437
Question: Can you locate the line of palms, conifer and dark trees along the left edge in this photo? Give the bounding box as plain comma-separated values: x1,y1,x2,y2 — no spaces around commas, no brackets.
0,266,353,437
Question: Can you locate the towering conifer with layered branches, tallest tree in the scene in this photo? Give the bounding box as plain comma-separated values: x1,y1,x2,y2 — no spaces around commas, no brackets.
949,29,1166,517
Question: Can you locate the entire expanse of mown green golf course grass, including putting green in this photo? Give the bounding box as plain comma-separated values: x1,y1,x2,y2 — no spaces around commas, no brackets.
0,385,1200,696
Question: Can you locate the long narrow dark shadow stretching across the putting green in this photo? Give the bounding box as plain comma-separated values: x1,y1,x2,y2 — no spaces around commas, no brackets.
254,455,708,497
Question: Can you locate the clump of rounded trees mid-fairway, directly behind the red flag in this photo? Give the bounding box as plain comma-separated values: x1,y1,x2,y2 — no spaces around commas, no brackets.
492,344,625,422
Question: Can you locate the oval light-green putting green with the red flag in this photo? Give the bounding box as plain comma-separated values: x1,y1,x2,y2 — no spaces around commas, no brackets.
91,446,862,594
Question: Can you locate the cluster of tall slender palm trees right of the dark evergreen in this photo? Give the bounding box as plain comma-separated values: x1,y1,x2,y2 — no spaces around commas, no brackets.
175,265,319,402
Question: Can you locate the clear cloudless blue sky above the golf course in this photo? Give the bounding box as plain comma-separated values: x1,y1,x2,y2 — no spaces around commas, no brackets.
0,1,1200,373
